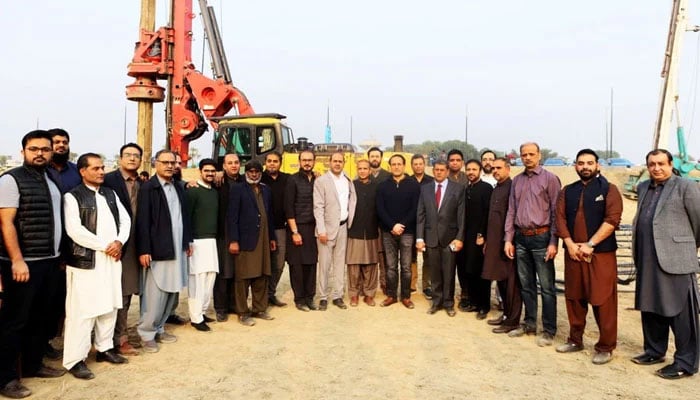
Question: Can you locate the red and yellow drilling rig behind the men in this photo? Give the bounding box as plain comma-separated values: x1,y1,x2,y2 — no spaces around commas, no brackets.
126,0,410,177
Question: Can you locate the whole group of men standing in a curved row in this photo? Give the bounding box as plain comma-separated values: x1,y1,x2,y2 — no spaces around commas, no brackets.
0,129,700,398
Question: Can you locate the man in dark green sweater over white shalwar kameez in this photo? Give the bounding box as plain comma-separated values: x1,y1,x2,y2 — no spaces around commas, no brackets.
186,158,219,332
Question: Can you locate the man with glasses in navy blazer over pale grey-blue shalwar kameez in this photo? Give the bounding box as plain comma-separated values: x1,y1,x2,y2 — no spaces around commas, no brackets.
136,150,192,353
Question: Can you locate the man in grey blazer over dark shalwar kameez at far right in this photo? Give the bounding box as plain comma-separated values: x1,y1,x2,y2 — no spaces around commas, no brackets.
632,149,700,379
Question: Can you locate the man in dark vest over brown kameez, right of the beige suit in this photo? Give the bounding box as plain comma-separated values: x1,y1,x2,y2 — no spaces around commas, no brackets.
345,160,379,307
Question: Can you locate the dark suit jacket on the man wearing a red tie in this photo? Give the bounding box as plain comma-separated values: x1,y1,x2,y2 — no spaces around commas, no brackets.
416,181,464,247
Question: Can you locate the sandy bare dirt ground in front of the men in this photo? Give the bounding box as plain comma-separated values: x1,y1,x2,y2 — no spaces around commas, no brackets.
24,167,700,399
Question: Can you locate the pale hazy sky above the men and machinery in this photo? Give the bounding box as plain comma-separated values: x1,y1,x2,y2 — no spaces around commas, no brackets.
0,0,700,162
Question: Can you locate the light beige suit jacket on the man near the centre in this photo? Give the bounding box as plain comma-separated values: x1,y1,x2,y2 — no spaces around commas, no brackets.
314,171,357,240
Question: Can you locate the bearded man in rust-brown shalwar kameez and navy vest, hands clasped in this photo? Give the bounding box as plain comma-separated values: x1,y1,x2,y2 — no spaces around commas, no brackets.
556,149,622,364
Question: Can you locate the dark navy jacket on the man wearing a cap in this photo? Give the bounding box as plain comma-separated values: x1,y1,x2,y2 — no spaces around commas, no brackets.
226,183,275,251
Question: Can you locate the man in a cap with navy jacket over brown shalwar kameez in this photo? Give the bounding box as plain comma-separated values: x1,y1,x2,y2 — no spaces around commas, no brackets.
227,160,277,326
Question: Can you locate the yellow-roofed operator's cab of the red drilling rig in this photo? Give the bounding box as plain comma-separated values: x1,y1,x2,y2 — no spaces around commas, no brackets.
212,114,294,168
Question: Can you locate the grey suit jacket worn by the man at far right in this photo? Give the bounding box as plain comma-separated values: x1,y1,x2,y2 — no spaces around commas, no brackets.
632,175,700,274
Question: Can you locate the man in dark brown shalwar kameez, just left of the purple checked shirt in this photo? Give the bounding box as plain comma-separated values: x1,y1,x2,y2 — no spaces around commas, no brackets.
481,157,523,333
